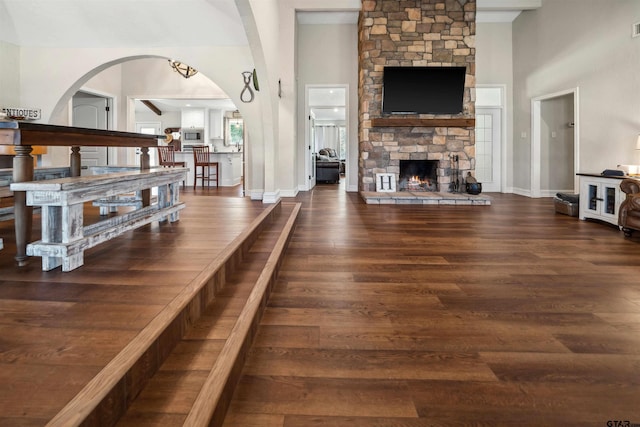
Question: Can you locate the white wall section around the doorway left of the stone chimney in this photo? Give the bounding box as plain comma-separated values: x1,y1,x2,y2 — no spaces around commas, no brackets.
297,24,359,191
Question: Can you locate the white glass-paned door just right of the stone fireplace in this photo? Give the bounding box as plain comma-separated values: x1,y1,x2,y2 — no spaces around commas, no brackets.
476,108,502,192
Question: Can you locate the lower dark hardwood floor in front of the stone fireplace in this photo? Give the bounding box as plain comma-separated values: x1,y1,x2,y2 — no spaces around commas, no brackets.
224,185,640,427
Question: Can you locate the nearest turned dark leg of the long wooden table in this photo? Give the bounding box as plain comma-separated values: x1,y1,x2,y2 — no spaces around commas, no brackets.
13,145,33,267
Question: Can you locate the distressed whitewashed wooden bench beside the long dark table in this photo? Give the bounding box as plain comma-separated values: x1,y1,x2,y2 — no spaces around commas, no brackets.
11,168,188,271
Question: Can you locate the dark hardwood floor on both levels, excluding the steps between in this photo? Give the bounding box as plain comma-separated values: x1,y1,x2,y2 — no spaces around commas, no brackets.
0,184,640,427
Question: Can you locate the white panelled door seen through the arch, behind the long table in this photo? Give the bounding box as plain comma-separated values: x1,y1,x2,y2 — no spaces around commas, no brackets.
72,92,109,174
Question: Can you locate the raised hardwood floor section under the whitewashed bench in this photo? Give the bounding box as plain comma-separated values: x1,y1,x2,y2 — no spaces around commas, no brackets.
0,186,266,426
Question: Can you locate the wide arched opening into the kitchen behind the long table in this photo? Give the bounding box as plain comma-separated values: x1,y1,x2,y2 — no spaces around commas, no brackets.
48,56,247,195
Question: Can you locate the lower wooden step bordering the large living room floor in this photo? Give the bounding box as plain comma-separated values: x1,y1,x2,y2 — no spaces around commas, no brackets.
117,204,300,427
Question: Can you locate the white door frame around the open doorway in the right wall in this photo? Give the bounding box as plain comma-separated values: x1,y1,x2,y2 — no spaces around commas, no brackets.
531,87,580,198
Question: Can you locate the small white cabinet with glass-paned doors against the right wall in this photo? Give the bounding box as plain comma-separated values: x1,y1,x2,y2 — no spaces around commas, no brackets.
578,174,625,225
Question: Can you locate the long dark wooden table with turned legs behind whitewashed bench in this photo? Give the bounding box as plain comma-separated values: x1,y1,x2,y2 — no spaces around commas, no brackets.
0,120,162,266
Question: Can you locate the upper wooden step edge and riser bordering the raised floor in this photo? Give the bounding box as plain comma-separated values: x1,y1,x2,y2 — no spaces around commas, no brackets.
47,203,294,426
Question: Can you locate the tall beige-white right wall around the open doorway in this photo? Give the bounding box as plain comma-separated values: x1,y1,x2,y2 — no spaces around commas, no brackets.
513,0,640,189
